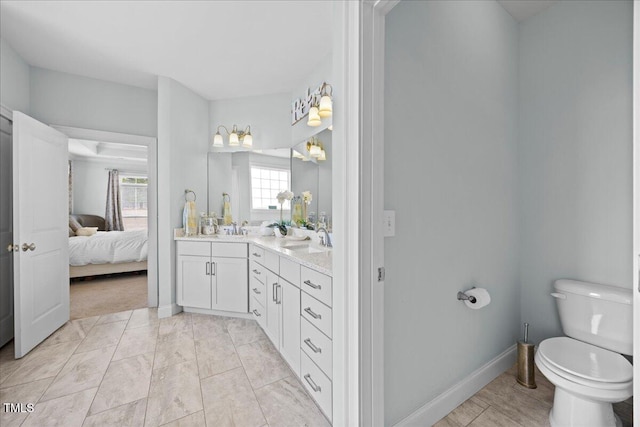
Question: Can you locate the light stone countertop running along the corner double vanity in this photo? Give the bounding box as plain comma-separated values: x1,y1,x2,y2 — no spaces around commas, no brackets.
174,228,333,276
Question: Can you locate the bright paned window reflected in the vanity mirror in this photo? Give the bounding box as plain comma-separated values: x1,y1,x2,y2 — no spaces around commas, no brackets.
251,166,290,210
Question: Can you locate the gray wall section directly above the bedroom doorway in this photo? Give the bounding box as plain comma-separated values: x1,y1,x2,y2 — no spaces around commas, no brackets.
30,67,158,136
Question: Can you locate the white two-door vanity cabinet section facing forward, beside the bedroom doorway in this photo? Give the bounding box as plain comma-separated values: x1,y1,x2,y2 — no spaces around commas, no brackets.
176,241,249,313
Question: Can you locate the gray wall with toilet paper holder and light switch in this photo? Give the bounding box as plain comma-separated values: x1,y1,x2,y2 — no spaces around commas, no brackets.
384,1,520,425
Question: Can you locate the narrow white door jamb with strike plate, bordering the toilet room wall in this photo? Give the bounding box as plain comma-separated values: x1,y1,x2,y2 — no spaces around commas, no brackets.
359,0,400,426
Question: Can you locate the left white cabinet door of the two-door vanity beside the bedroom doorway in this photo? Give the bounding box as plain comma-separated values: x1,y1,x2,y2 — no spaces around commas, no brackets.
176,255,213,308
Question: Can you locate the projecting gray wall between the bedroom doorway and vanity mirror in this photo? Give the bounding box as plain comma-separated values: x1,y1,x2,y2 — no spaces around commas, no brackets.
158,77,210,316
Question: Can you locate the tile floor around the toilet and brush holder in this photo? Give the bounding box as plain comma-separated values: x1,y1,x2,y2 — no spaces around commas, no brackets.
434,365,633,427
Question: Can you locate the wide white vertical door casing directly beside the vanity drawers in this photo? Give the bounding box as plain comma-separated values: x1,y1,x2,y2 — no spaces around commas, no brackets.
332,1,362,426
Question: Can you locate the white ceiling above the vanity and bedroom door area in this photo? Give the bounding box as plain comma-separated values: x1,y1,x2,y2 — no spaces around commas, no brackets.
0,0,332,100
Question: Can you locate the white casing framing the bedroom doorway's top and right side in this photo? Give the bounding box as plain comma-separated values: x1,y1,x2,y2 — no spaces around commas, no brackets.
51,125,159,307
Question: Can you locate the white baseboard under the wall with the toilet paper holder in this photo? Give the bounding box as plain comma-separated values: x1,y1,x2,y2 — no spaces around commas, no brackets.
395,345,516,427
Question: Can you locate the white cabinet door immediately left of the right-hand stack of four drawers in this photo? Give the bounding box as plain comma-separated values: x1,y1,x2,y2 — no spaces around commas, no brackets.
278,279,300,377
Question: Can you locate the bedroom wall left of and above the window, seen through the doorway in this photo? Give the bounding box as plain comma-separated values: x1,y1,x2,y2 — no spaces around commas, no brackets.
73,159,147,221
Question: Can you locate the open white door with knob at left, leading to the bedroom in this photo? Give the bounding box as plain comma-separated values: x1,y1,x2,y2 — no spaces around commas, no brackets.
13,112,69,357
